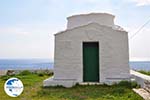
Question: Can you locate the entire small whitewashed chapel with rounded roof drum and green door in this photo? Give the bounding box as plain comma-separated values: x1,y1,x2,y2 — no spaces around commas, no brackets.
44,13,130,87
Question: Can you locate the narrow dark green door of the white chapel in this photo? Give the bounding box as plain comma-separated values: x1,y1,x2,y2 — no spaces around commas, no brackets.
83,42,99,82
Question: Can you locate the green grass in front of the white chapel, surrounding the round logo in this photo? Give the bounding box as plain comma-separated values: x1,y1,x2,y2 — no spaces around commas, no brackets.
0,72,143,100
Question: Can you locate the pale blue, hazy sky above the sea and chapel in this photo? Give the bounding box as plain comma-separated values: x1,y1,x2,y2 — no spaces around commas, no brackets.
0,0,150,60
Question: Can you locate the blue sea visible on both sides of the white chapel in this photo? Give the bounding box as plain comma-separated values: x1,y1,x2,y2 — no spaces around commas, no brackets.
0,59,150,71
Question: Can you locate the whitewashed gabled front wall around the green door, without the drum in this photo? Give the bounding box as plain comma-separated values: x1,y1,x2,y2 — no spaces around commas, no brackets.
54,23,130,83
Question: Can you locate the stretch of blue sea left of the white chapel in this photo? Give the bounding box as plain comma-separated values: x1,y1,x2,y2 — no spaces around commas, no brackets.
0,59,54,70
